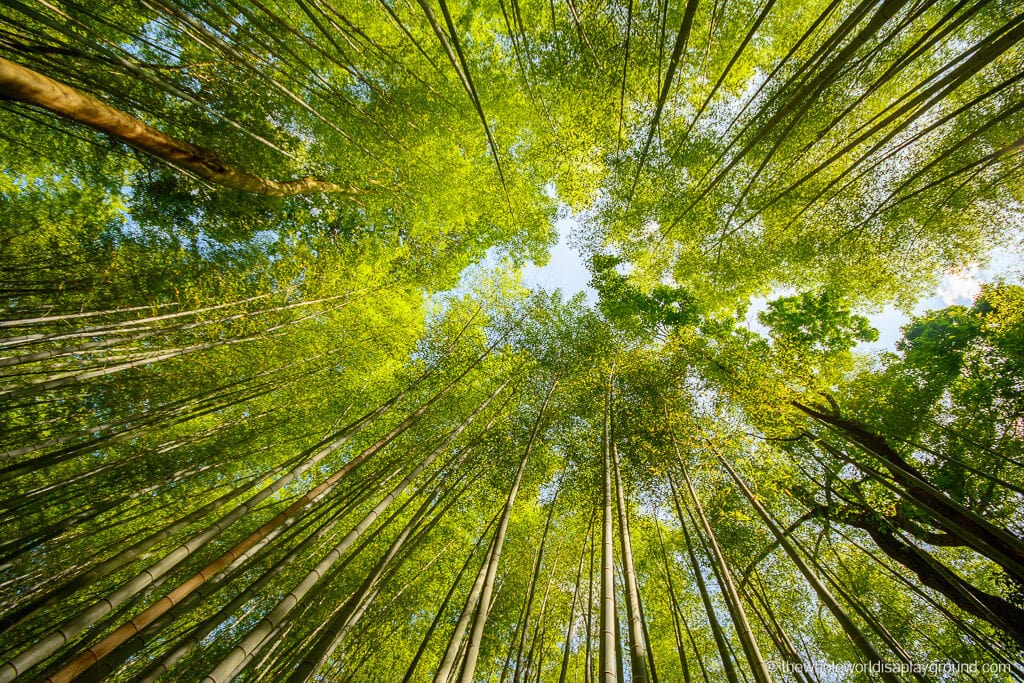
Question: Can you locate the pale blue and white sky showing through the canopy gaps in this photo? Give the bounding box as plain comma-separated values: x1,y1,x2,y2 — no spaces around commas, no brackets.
522,216,1022,352
